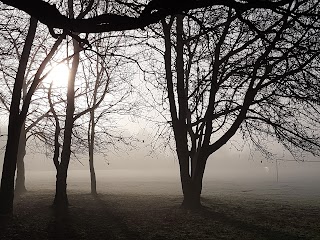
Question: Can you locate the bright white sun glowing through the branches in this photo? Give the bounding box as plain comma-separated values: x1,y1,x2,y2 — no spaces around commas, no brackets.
44,63,70,88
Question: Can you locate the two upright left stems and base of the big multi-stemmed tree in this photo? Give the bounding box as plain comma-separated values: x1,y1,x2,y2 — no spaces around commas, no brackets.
162,16,204,209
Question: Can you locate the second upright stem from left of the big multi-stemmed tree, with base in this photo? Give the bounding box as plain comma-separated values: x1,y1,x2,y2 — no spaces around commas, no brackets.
173,15,204,209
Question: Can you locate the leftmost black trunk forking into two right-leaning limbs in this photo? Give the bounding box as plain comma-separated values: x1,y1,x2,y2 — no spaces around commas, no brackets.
0,13,67,213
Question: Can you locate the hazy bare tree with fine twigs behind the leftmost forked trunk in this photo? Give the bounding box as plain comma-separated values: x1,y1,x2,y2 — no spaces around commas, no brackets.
0,10,61,194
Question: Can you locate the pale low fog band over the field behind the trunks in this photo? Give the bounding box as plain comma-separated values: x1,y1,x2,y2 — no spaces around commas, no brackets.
0,126,320,202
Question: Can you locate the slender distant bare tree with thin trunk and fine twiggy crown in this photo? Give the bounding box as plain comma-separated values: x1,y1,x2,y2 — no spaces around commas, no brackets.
85,34,136,195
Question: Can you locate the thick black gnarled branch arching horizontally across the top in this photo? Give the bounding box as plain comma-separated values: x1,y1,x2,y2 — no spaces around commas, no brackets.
1,0,295,33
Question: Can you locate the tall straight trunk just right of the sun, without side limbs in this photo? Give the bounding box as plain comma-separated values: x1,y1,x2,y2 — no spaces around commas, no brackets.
53,36,81,209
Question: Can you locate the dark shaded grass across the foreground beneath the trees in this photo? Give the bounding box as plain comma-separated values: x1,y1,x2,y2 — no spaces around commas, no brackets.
0,191,320,240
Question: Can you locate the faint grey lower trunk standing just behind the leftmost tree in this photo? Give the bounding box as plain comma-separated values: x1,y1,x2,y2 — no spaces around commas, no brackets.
15,124,27,195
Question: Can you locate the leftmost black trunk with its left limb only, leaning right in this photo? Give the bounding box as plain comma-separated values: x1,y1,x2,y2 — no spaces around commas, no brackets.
0,18,37,213
